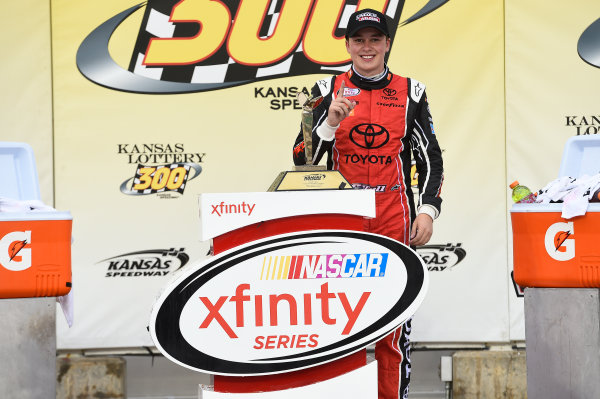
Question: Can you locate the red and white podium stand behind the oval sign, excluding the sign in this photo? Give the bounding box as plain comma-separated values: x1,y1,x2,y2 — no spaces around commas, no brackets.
200,190,377,399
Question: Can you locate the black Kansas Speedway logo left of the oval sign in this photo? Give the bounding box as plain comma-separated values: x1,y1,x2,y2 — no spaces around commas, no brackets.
98,248,190,278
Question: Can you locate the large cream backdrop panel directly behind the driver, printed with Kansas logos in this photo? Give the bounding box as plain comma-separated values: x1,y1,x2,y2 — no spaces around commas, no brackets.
51,0,510,348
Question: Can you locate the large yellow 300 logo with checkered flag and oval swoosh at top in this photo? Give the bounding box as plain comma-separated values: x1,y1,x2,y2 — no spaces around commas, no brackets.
76,0,448,94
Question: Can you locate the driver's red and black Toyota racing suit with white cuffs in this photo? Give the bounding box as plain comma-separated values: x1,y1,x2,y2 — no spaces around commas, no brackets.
293,66,443,399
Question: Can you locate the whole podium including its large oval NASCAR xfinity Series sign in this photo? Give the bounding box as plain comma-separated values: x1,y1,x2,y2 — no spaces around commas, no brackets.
150,190,429,399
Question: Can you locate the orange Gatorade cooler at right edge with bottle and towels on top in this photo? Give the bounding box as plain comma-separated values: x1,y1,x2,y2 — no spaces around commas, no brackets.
511,136,600,288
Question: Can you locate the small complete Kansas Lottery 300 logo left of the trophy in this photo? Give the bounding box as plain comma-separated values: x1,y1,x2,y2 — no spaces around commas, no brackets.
117,143,206,198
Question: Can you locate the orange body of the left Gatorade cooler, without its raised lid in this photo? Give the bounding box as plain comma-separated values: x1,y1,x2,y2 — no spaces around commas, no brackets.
0,211,72,298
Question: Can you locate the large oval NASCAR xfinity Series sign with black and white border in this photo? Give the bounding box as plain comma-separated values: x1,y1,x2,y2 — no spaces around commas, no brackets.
150,230,428,376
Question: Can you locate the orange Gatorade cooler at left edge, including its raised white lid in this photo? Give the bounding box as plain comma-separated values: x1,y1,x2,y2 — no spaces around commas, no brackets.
0,142,72,298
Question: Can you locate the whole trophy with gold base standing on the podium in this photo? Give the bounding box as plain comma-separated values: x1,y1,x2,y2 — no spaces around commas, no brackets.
268,89,352,191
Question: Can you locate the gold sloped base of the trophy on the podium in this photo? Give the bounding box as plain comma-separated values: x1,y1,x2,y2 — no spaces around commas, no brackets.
267,165,352,191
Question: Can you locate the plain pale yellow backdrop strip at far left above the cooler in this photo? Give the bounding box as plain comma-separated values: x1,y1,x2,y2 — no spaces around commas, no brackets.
0,0,53,205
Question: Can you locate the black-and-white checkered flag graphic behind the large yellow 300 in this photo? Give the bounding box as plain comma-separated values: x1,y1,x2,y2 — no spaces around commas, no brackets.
129,0,404,83
